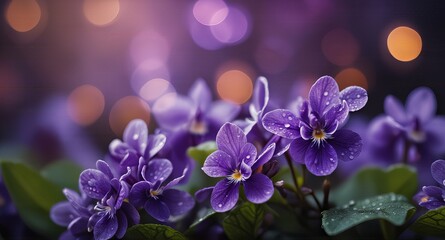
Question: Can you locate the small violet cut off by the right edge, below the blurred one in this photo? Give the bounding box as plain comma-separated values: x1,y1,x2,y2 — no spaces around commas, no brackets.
414,159,445,209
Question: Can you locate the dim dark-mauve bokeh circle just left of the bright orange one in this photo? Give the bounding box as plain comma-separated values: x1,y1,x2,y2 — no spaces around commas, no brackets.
321,29,360,66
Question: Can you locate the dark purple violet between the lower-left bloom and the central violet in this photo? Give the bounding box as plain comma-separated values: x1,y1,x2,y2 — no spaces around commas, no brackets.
129,159,195,222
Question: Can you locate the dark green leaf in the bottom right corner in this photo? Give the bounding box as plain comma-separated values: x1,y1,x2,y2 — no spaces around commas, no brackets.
411,207,445,237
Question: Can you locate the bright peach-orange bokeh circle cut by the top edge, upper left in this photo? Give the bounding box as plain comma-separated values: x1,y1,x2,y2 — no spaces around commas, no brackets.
83,0,120,26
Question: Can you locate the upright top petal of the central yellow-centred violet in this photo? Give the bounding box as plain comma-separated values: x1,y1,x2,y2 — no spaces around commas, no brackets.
216,123,247,159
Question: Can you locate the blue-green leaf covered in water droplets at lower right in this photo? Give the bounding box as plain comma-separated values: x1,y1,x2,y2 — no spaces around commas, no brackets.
321,193,415,236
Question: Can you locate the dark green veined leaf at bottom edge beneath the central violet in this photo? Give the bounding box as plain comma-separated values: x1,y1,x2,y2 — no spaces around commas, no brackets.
223,202,264,239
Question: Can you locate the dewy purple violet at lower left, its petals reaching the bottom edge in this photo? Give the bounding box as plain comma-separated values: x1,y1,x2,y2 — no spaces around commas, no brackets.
79,160,140,239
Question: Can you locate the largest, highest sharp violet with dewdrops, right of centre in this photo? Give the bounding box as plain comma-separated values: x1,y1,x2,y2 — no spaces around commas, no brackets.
263,76,368,176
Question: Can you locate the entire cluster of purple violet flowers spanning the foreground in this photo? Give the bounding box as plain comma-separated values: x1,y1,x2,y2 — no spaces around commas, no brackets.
42,76,445,239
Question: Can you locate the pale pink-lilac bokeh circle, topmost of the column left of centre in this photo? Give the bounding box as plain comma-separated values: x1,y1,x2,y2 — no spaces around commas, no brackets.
130,31,170,68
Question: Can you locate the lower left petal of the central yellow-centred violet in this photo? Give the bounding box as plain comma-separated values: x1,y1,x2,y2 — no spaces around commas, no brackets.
210,179,239,212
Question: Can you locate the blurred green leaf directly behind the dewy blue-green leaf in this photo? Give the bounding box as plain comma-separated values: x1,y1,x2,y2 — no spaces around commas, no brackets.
330,165,418,204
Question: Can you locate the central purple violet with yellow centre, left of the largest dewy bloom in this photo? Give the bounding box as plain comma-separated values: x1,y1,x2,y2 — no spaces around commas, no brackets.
202,123,275,212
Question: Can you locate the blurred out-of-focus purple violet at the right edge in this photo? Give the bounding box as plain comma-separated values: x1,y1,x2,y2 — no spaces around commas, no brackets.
369,87,445,162
